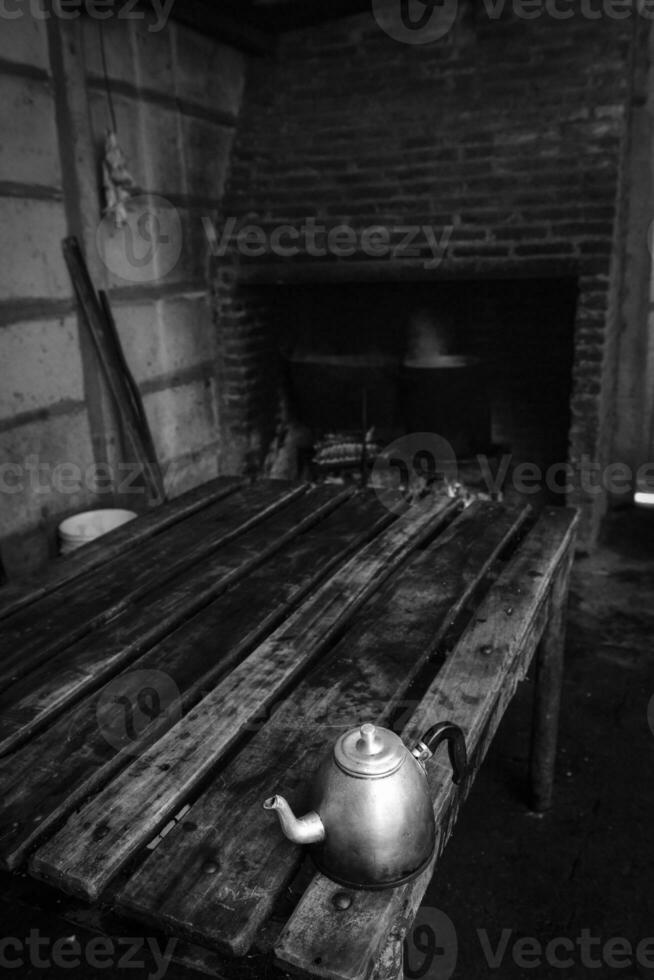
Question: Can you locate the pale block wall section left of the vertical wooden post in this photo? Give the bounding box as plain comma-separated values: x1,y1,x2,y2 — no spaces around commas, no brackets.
0,17,94,573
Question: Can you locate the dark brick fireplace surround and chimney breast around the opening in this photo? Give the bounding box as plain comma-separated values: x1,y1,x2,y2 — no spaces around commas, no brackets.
214,3,638,541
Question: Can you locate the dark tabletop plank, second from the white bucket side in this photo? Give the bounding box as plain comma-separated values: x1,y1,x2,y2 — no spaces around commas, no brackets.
0,481,307,684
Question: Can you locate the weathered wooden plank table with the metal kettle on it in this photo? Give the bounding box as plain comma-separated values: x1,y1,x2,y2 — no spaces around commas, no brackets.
0,479,576,980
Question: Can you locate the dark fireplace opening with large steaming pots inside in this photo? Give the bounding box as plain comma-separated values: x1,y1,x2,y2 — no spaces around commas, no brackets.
259,277,578,501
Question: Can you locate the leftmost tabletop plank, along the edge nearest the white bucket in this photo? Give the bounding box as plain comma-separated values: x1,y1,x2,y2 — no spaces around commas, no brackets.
0,476,245,620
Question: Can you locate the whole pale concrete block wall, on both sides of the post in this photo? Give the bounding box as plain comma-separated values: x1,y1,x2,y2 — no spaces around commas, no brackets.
0,15,246,577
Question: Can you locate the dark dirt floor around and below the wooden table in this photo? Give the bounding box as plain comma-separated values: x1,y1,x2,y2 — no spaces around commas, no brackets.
0,512,654,980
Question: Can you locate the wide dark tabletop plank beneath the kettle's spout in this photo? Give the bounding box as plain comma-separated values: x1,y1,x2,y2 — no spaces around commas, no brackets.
117,503,528,956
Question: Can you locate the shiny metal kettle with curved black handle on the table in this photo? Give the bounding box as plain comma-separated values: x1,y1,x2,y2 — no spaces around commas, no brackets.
263,722,467,889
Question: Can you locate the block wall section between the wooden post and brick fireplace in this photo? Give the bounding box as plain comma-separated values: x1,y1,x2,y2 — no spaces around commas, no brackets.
84,20,245,494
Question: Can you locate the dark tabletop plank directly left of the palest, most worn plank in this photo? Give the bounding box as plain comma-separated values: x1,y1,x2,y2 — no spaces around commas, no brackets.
0,487,382,868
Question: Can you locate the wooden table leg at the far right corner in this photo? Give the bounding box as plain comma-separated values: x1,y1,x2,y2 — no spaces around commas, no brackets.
530,552,574,813
